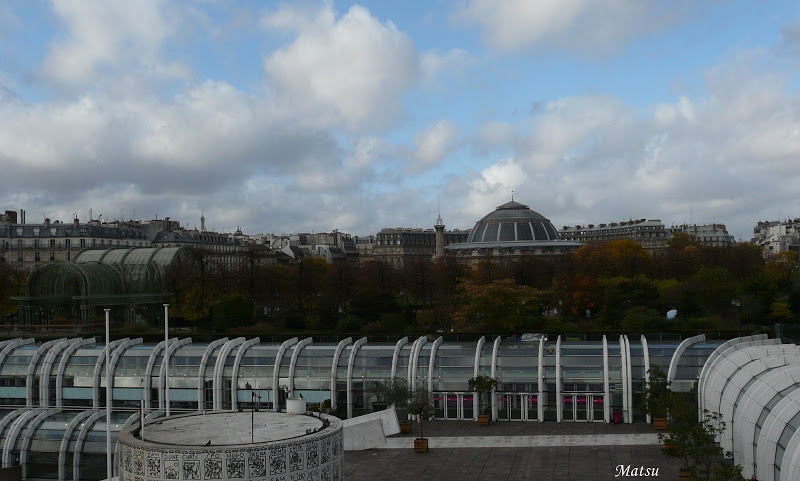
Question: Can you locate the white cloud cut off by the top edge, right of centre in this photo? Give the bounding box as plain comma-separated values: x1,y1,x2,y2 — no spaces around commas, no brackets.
455,0,697,54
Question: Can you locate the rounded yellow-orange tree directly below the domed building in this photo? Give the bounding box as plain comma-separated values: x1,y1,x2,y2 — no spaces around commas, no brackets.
453,279,541,332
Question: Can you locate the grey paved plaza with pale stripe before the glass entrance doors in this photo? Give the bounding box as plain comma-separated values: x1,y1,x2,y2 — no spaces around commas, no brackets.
345,421,679,481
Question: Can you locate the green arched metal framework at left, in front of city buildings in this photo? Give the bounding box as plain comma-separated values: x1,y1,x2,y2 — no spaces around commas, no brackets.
14,247,185,325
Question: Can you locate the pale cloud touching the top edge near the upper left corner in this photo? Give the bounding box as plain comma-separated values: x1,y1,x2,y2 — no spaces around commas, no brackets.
41,0,181,88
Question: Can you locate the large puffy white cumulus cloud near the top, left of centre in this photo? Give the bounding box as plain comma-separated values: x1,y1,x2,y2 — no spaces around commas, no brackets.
263,5,418,132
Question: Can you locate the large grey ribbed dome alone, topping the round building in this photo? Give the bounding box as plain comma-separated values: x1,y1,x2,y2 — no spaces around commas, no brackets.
467,200,559,244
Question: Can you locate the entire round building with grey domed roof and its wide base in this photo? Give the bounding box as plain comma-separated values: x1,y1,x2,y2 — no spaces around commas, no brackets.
444,200,583,262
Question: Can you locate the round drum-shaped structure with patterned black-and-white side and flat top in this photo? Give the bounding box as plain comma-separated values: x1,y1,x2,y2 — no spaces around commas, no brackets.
118,411,344,481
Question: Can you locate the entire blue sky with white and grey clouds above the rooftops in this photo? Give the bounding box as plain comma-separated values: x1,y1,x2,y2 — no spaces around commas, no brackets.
0,0,800,240
